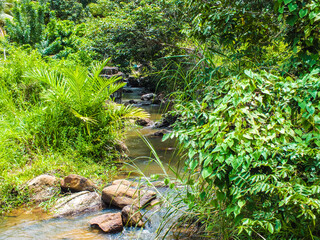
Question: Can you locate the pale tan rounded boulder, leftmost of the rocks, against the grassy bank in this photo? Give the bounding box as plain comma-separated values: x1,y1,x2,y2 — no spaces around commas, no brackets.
27,174,60,202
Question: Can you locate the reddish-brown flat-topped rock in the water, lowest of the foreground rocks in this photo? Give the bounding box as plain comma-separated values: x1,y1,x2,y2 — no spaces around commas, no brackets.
89,213,123,233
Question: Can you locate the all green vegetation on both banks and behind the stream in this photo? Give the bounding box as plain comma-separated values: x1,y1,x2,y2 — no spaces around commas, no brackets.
0,0,320,239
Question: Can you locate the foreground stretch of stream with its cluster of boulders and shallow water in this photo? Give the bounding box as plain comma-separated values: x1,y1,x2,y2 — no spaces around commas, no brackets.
0,174,182,240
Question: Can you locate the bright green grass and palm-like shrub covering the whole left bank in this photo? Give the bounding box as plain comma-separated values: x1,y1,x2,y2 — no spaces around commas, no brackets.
0,48,148,211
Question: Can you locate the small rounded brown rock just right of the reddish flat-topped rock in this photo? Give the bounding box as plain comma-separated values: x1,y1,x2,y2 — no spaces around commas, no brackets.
121,205,144,227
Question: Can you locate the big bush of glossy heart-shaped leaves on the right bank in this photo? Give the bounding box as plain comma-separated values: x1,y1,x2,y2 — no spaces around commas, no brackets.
167,69,320,239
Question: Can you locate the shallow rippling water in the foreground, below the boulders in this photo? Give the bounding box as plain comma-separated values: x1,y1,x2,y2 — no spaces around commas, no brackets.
0,203,180,240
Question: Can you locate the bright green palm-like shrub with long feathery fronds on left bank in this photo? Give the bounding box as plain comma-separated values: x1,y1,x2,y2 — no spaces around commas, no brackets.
25,59,148,156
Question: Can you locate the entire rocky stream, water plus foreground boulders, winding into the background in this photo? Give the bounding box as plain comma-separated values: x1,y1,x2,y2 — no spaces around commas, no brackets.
0,85,185,240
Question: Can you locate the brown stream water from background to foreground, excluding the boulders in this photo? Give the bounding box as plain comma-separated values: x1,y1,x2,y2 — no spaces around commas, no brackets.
0,88,178,240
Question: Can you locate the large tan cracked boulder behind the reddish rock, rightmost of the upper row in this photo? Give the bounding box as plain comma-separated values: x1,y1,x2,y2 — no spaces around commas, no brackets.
102,184,156,208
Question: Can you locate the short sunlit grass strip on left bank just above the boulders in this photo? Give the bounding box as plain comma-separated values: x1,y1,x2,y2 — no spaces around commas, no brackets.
0,144,118,214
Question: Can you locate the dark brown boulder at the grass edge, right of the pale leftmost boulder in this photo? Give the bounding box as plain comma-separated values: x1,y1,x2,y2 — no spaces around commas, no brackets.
61,174,96,192
